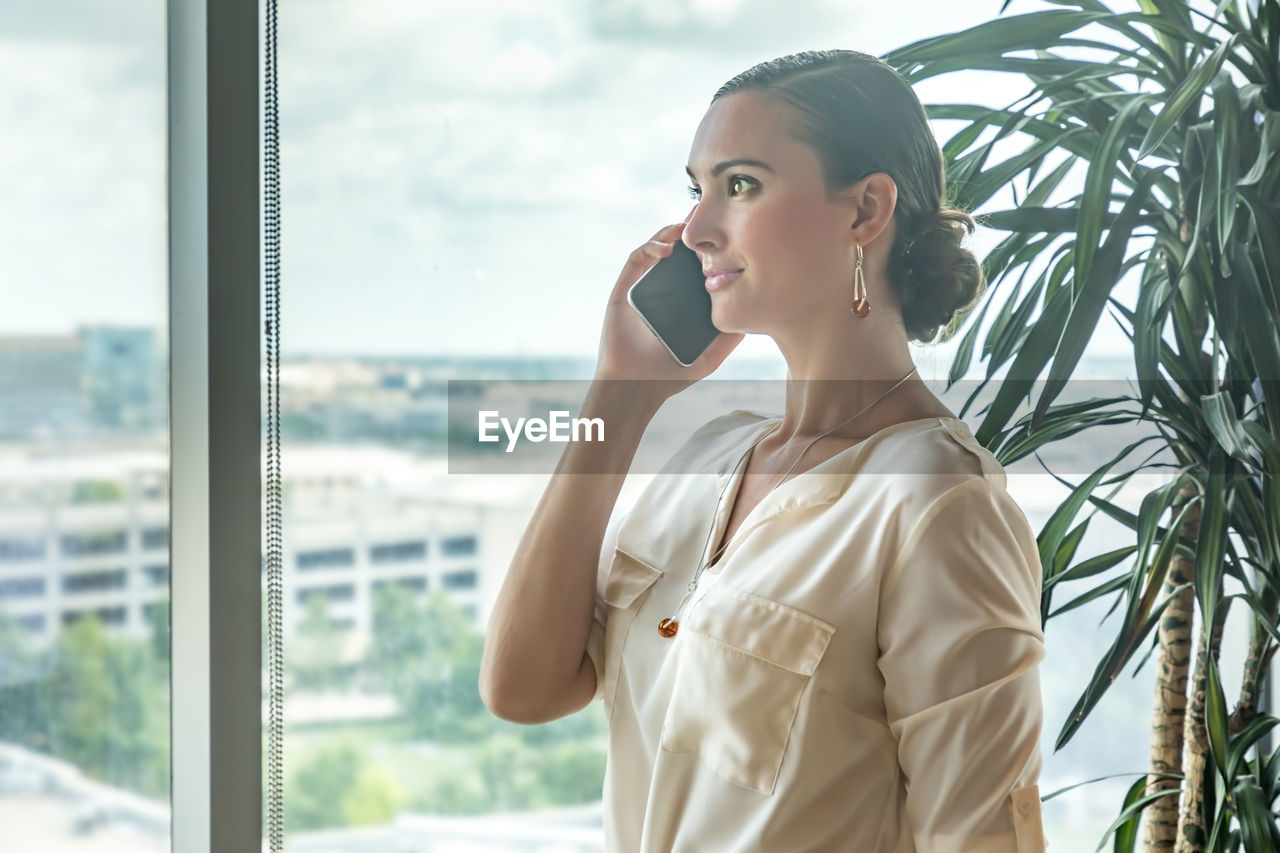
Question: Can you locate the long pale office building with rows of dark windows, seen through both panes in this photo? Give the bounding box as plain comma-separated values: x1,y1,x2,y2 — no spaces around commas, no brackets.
0,446,555,654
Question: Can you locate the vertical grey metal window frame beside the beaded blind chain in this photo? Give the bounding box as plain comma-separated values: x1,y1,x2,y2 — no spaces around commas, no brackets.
165,0,264,853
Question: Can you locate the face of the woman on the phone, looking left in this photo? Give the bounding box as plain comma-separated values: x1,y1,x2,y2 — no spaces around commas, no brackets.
681,92,856,334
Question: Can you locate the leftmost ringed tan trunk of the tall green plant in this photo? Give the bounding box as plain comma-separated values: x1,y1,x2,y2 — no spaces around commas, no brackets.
1143,484,1201,853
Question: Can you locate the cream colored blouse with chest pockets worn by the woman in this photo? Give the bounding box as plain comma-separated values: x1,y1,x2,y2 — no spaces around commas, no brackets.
588,410,1046,853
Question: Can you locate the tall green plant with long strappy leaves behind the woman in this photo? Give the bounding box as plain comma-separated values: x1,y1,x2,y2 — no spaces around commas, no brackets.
883,0,1280,853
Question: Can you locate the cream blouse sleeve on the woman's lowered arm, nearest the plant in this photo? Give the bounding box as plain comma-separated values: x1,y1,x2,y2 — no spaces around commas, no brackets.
877,478,1046,853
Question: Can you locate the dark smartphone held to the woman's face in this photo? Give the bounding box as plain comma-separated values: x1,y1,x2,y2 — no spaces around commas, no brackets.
627,240,721,368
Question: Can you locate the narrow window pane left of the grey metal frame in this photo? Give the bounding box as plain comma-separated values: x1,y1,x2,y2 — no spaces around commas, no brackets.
0,0,170,853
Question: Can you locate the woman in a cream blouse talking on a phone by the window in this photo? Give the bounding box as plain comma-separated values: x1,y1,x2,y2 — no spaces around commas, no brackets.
481,50,1044,853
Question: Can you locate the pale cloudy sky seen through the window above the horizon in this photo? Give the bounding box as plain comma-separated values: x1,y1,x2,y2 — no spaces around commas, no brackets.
0,0,1182,375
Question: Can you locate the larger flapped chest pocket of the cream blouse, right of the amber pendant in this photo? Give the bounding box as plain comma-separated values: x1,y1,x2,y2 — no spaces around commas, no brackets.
659,588,836,794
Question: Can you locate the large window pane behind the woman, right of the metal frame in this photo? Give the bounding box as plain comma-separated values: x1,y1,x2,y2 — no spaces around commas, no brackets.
264,0,1254,850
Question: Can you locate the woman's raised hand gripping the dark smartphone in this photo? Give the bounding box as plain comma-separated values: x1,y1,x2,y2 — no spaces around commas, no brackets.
595,207,746,398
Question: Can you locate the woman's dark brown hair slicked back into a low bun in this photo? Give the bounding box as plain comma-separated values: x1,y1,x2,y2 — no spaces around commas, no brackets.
712,50,986,343
